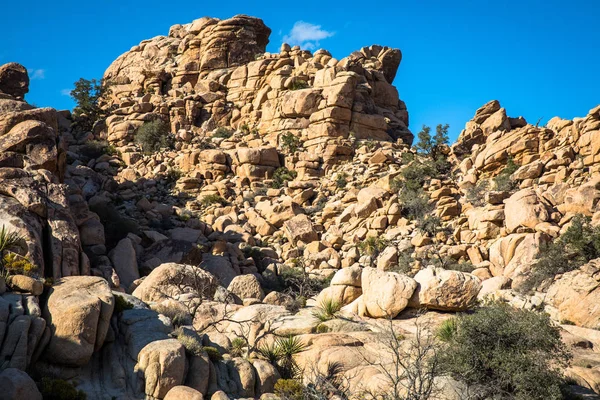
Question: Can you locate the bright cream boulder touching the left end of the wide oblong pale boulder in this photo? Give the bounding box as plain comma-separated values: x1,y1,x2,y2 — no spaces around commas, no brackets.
359,268,417,318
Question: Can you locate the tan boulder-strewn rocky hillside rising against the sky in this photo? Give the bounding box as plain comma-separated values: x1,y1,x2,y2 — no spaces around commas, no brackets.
0,16,600,400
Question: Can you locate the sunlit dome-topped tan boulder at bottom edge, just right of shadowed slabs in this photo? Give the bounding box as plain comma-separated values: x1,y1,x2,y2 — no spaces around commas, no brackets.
136,339,185,399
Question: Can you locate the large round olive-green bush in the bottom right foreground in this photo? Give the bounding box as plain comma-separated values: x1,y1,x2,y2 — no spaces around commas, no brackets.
438,304,569,400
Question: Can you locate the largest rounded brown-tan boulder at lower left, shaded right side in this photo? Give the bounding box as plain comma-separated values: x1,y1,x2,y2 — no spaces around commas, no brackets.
43,276,115,367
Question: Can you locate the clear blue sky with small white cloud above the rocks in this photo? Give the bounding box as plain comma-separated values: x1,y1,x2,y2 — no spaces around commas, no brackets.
0,0,600,139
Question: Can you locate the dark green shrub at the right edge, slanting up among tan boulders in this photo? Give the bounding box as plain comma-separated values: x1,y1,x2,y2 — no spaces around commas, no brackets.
521,215,600,292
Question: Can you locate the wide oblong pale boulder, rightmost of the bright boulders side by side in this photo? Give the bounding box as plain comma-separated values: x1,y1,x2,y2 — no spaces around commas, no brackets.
410,267,481,311
